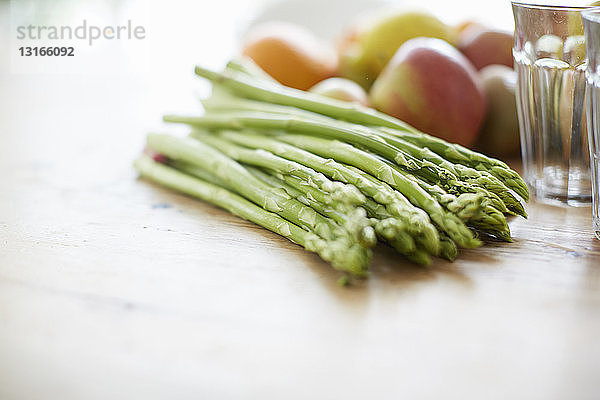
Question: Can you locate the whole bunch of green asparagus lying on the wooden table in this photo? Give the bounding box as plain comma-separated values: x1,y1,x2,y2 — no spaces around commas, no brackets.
135,60,529,278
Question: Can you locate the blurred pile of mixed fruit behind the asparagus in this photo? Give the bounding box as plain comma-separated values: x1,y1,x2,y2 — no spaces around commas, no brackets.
242,9,519,158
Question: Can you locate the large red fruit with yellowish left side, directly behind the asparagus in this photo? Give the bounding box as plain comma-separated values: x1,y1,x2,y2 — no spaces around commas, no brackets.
369,38,486,146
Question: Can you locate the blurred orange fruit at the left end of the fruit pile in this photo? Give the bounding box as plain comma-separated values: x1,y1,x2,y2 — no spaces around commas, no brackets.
242,22,337,90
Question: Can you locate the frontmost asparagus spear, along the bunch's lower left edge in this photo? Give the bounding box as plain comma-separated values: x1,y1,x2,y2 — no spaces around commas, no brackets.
135,156,366,277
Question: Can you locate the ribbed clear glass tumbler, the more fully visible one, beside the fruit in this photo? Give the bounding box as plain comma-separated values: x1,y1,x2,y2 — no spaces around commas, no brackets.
512,1,591,206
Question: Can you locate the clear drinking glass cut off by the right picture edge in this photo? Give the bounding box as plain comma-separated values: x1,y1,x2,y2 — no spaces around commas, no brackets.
582,9,600,239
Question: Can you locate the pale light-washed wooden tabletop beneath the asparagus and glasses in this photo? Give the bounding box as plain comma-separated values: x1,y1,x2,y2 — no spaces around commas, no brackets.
0,0,600,400
